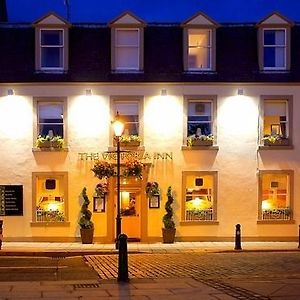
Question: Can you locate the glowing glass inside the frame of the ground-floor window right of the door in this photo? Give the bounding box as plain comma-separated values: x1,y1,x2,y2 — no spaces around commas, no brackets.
185,174,214,221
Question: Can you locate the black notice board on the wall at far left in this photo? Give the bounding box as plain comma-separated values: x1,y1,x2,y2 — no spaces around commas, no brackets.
0,185,23,216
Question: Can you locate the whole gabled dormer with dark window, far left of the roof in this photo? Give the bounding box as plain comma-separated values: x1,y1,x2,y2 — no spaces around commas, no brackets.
34,13,70,73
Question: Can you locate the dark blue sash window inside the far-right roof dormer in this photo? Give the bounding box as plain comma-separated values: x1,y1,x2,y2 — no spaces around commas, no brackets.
263,29,287,70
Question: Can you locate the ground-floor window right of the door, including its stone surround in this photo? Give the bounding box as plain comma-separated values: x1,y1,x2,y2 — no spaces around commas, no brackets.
182,171,217,221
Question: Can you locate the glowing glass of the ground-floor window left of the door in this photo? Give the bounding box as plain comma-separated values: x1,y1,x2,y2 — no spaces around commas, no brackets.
36,176,65,222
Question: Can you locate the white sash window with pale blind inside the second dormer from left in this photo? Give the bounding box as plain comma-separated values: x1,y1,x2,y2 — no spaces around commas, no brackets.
114,28,140,70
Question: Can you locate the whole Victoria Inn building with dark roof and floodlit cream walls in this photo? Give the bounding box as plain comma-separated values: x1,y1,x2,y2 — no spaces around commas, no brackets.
0,1,300,243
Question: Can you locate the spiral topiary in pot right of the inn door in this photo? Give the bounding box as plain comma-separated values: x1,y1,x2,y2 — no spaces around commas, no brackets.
162,186,176,244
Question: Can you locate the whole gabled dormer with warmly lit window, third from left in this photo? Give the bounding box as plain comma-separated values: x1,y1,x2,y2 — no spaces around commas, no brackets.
182,13,219,72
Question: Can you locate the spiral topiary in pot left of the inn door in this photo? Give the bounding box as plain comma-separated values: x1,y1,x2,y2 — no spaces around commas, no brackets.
79,187,94,244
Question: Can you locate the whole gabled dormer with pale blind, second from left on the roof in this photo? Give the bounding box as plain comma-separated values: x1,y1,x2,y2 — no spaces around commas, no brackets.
109,13,145,72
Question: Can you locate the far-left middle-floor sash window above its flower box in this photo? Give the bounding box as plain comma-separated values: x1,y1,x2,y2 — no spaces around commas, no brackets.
37,101,65,138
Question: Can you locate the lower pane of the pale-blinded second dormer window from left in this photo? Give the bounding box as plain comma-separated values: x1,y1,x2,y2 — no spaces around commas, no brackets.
116,47,139,69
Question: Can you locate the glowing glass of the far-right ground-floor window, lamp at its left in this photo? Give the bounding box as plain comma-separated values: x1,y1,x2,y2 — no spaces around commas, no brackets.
261,174,290,220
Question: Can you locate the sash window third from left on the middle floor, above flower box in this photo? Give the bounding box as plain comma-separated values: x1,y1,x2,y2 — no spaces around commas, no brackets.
187,99,214,137
